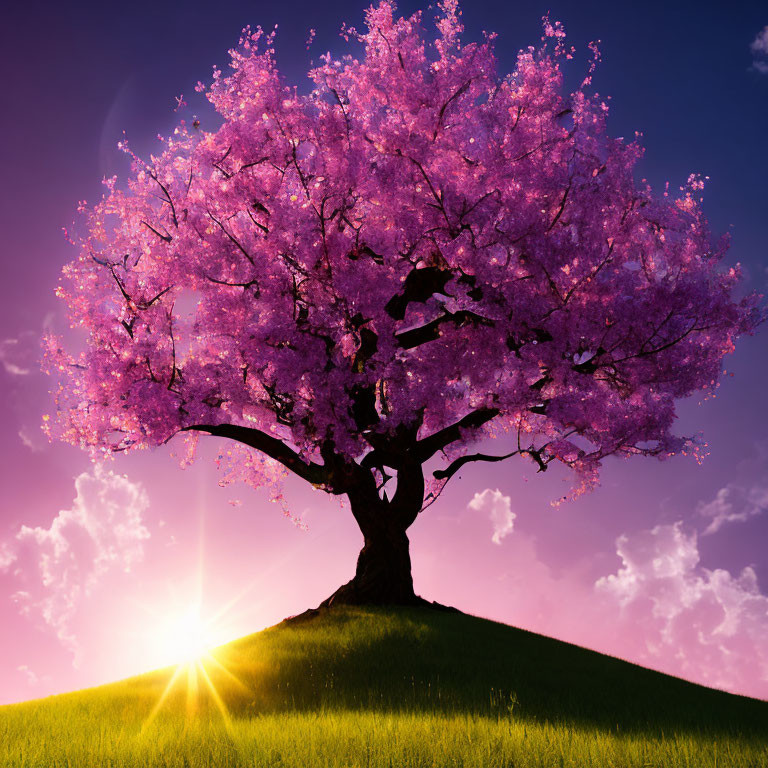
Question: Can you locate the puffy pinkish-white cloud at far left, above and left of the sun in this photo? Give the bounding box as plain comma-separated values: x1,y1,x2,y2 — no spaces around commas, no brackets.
7,466,150,663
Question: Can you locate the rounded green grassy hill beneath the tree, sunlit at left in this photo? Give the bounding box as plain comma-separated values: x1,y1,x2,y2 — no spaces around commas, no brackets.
0,609,768,768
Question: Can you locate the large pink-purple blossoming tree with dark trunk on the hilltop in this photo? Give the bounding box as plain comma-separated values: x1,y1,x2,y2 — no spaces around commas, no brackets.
45,0,763,603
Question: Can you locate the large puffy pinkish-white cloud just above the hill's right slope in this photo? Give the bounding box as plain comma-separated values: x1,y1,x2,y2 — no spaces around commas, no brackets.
595,522,768,690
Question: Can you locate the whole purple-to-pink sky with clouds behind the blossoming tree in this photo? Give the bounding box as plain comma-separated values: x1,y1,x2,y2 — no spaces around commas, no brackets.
0,0,768,704
